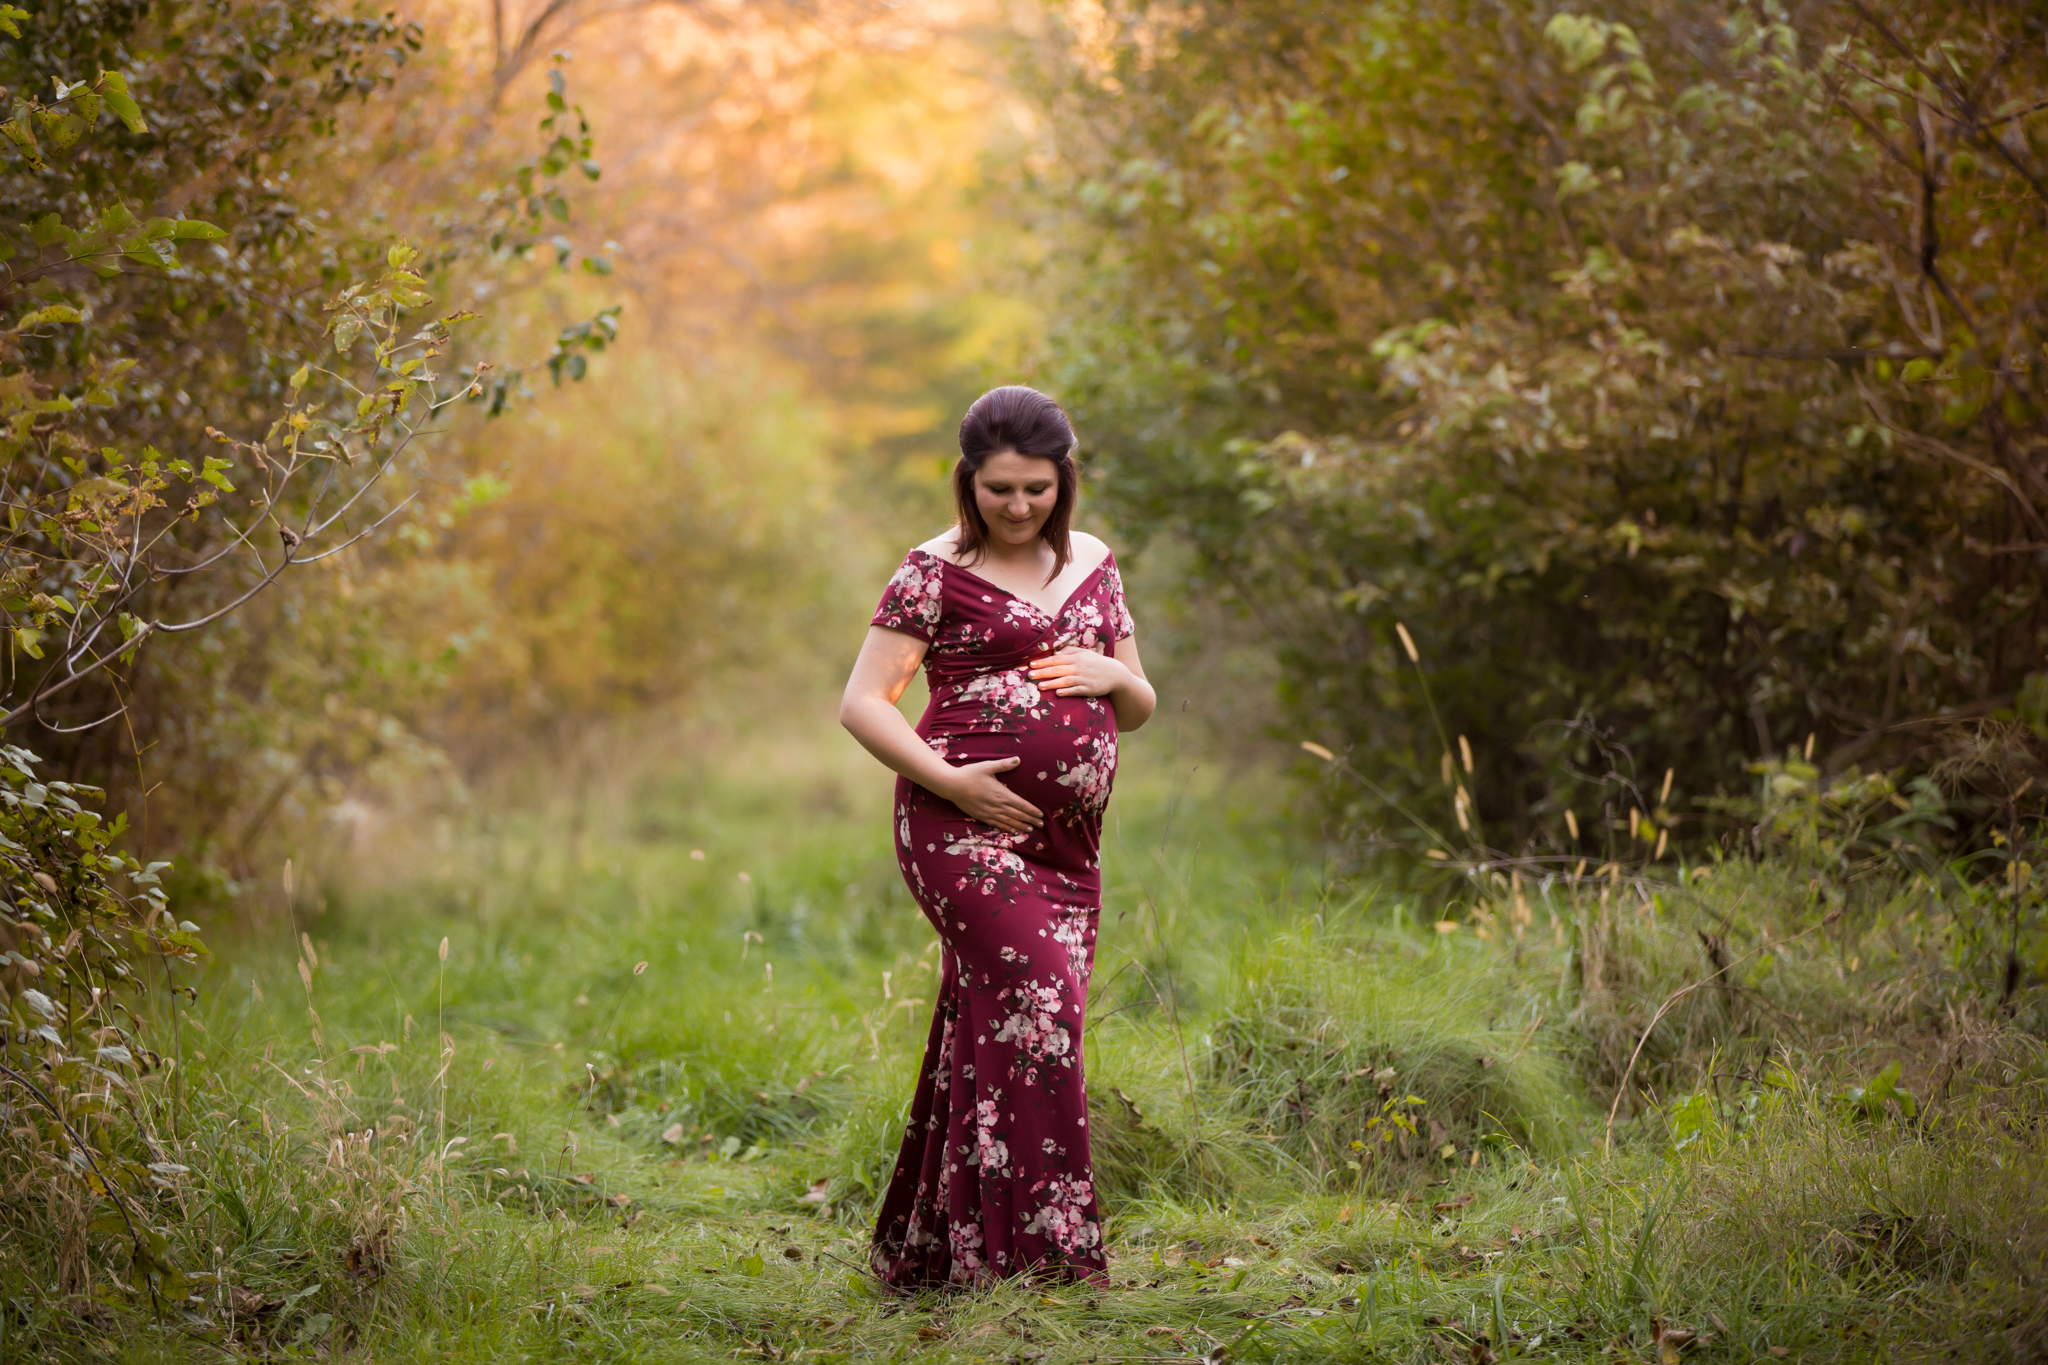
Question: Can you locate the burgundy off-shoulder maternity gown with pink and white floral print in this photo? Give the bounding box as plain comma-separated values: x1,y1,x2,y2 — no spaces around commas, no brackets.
870,551,1133,1289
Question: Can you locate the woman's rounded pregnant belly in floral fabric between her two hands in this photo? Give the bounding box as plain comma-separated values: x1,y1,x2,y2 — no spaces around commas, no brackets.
918,696,1116,821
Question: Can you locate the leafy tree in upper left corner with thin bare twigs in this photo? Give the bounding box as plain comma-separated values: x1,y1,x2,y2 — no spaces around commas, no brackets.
0,0,614,859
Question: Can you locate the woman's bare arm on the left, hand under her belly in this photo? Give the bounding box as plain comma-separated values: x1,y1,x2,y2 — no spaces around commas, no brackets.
840,626,1044,835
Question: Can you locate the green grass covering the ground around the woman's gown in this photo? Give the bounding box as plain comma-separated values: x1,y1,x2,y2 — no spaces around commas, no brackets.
0,733,2048,1365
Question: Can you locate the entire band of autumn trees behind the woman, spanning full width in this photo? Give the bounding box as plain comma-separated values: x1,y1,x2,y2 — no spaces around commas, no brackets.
6,0,2048,908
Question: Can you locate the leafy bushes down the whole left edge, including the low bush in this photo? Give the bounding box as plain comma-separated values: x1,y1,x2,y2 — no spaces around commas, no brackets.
0,0,612,1314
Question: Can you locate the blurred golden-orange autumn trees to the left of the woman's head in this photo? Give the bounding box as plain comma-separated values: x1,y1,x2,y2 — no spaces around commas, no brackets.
6,0,1026,896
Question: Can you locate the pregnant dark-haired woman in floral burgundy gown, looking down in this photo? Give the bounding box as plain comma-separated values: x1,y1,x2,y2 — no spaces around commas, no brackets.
840,387,1155,1289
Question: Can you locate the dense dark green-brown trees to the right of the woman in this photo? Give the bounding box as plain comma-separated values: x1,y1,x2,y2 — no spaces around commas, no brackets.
1040,0,2048,853
